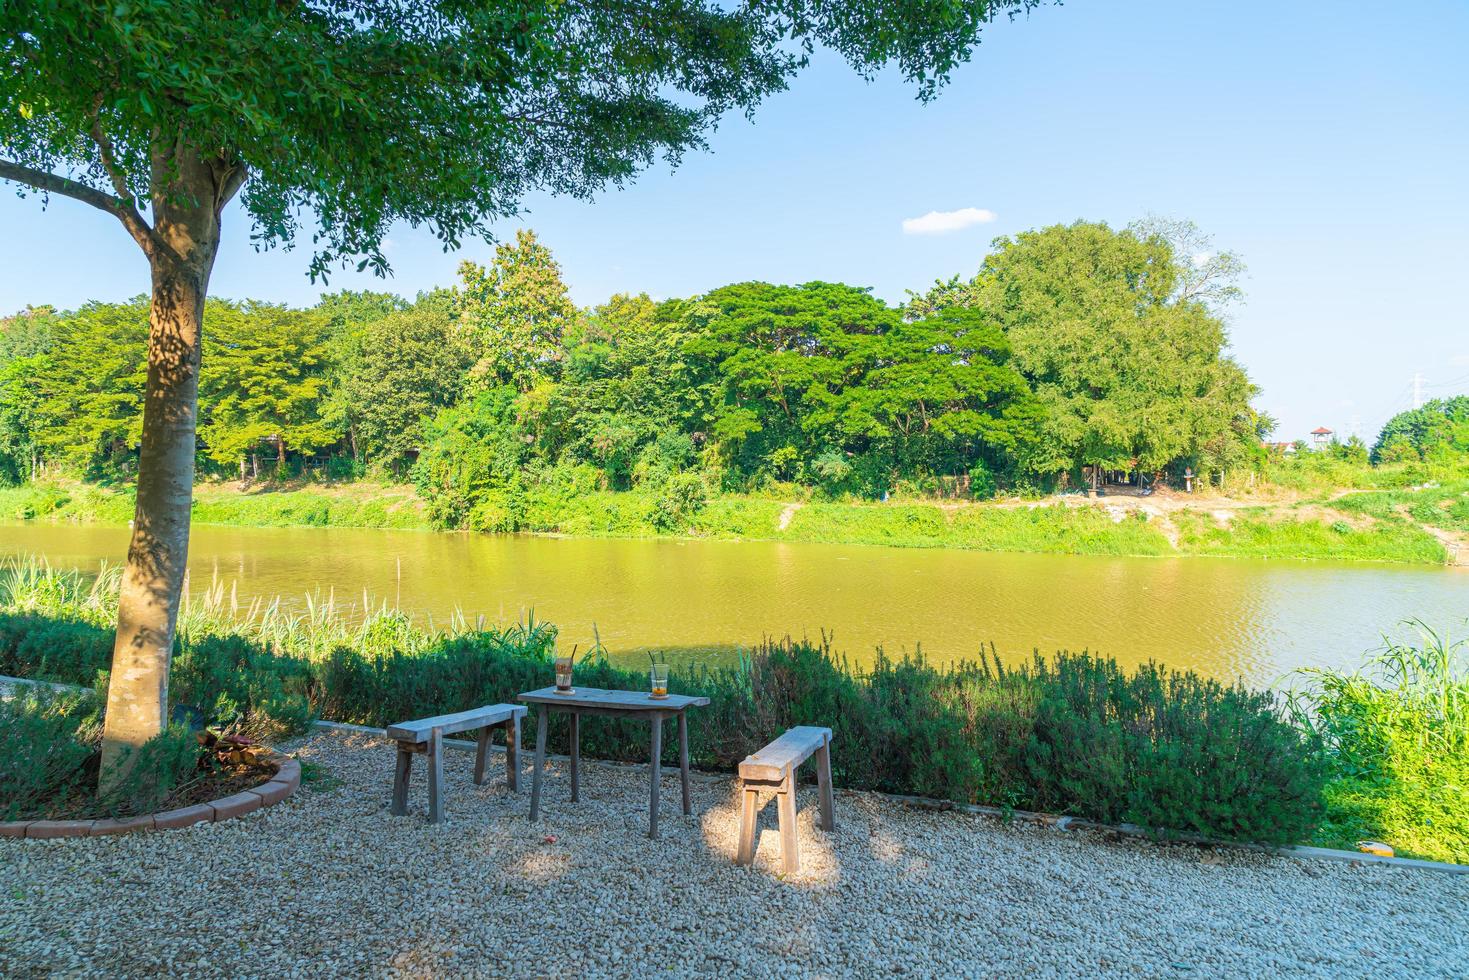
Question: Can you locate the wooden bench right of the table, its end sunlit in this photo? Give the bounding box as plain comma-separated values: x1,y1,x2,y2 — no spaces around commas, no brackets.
735,726,836,874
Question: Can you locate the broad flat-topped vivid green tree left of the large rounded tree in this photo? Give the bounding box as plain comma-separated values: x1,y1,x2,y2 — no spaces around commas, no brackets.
687,282,1040,494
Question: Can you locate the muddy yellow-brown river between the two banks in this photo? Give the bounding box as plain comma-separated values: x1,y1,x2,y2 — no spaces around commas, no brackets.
0,525,1469,686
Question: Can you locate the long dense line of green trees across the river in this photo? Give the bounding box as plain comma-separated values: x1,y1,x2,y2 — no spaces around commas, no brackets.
0,222,1269,526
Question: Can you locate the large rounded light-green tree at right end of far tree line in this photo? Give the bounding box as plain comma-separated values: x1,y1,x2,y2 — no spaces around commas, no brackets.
909,222,1259,481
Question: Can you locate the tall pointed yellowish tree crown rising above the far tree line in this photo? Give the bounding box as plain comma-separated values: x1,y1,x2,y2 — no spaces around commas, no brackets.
455,229,577,391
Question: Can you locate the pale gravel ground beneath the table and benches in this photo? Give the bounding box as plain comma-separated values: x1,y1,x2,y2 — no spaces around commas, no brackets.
0,731,1469,977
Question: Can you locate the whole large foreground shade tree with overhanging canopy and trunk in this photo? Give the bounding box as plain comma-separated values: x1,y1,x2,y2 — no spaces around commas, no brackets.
0,0,1037,780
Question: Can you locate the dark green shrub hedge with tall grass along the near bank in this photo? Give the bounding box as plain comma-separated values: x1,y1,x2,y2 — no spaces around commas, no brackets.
0,563,1325,842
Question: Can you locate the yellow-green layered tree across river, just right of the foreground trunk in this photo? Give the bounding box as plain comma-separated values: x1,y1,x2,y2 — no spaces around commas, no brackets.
200,300,341,476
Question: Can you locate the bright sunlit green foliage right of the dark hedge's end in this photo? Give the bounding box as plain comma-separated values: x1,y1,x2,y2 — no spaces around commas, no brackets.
1291,623,1469,864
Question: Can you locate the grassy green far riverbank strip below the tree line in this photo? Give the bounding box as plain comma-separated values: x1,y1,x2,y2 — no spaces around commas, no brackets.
0,482,1469,564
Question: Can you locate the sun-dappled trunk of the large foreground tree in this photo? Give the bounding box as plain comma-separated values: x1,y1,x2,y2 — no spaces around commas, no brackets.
100,140,244,792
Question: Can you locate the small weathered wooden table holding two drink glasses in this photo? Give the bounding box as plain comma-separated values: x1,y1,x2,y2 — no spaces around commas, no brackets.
520,688,710,837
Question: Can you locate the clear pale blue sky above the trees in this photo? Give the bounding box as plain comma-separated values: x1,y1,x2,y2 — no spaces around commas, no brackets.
0,0,1469,438
